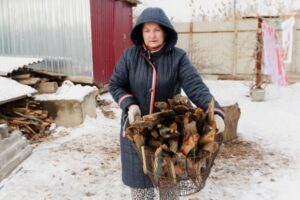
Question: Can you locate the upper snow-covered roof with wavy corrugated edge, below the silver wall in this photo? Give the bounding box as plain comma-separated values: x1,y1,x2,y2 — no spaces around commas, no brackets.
0,56,43,76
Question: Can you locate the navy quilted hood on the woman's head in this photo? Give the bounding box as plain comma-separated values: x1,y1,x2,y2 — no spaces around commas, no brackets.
130,8,178,47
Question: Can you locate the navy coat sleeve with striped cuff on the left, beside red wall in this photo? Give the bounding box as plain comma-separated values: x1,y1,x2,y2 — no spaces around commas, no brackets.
108,51,137,112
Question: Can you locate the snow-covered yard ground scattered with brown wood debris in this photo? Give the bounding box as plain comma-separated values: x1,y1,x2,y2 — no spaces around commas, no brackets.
0,80,300,200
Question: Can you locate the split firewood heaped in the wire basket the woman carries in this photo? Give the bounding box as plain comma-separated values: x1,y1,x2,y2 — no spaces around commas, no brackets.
125,95,222,194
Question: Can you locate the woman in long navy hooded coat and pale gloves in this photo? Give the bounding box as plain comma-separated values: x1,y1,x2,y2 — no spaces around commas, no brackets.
109,8,225,199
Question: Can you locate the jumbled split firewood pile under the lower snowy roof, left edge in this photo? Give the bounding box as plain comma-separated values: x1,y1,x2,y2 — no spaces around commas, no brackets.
0,98,53,142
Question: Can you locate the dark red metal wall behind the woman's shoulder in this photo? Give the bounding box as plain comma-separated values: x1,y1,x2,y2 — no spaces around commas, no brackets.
90,0,132,83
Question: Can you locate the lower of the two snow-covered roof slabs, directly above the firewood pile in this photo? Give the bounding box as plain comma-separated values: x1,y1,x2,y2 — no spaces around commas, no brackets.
0,76,37,105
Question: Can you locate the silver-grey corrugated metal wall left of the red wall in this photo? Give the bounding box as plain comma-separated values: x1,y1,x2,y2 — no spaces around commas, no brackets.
0,0,92,76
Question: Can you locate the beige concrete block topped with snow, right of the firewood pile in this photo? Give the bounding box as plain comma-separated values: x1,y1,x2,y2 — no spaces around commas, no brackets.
41,92,97,127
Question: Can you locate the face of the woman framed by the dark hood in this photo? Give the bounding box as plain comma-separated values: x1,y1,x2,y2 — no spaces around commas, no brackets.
142,22,166,50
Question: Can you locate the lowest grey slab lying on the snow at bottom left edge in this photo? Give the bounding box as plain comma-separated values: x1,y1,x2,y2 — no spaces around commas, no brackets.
0,146,32,181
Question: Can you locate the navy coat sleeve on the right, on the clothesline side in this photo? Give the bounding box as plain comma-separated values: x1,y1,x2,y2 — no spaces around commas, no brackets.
179,54,224,119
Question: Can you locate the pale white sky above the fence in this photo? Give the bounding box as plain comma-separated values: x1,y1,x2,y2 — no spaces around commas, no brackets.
134,0,300,22
